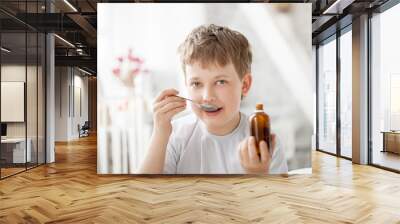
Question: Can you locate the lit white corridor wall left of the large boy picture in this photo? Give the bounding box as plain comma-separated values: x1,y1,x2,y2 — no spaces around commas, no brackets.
55,67,88,141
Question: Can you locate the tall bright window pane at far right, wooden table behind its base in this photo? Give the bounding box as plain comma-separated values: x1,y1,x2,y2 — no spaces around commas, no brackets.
371,4,400,170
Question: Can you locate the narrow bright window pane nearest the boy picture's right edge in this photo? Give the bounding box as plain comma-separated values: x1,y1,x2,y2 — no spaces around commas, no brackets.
318,39,336,153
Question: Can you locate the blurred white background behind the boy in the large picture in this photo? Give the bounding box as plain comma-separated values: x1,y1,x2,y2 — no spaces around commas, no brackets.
97,3,315,174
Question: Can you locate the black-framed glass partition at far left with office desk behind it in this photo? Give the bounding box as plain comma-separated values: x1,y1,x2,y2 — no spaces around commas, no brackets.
0,1,46,179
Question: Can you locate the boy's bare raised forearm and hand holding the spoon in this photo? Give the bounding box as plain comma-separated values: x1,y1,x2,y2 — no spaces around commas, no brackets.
139,89,186,174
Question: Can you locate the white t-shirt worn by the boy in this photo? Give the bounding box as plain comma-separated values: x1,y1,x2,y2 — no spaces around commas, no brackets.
164,113,288,174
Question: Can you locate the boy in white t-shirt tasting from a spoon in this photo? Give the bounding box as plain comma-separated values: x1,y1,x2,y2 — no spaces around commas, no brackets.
139,25,287,174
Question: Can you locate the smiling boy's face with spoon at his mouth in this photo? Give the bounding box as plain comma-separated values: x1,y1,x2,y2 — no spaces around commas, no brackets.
185,63,251,135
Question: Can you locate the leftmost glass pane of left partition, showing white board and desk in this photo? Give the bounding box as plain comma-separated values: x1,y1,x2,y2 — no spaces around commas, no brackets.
0,32,27,178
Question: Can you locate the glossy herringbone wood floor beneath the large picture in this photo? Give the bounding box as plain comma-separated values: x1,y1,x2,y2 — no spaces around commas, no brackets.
0,134,400,224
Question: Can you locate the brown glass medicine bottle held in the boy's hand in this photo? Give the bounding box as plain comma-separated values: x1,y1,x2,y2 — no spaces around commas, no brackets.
249,103,271,156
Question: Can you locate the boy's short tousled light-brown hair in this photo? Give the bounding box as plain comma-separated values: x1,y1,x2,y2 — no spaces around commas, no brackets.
178,24,252,79
